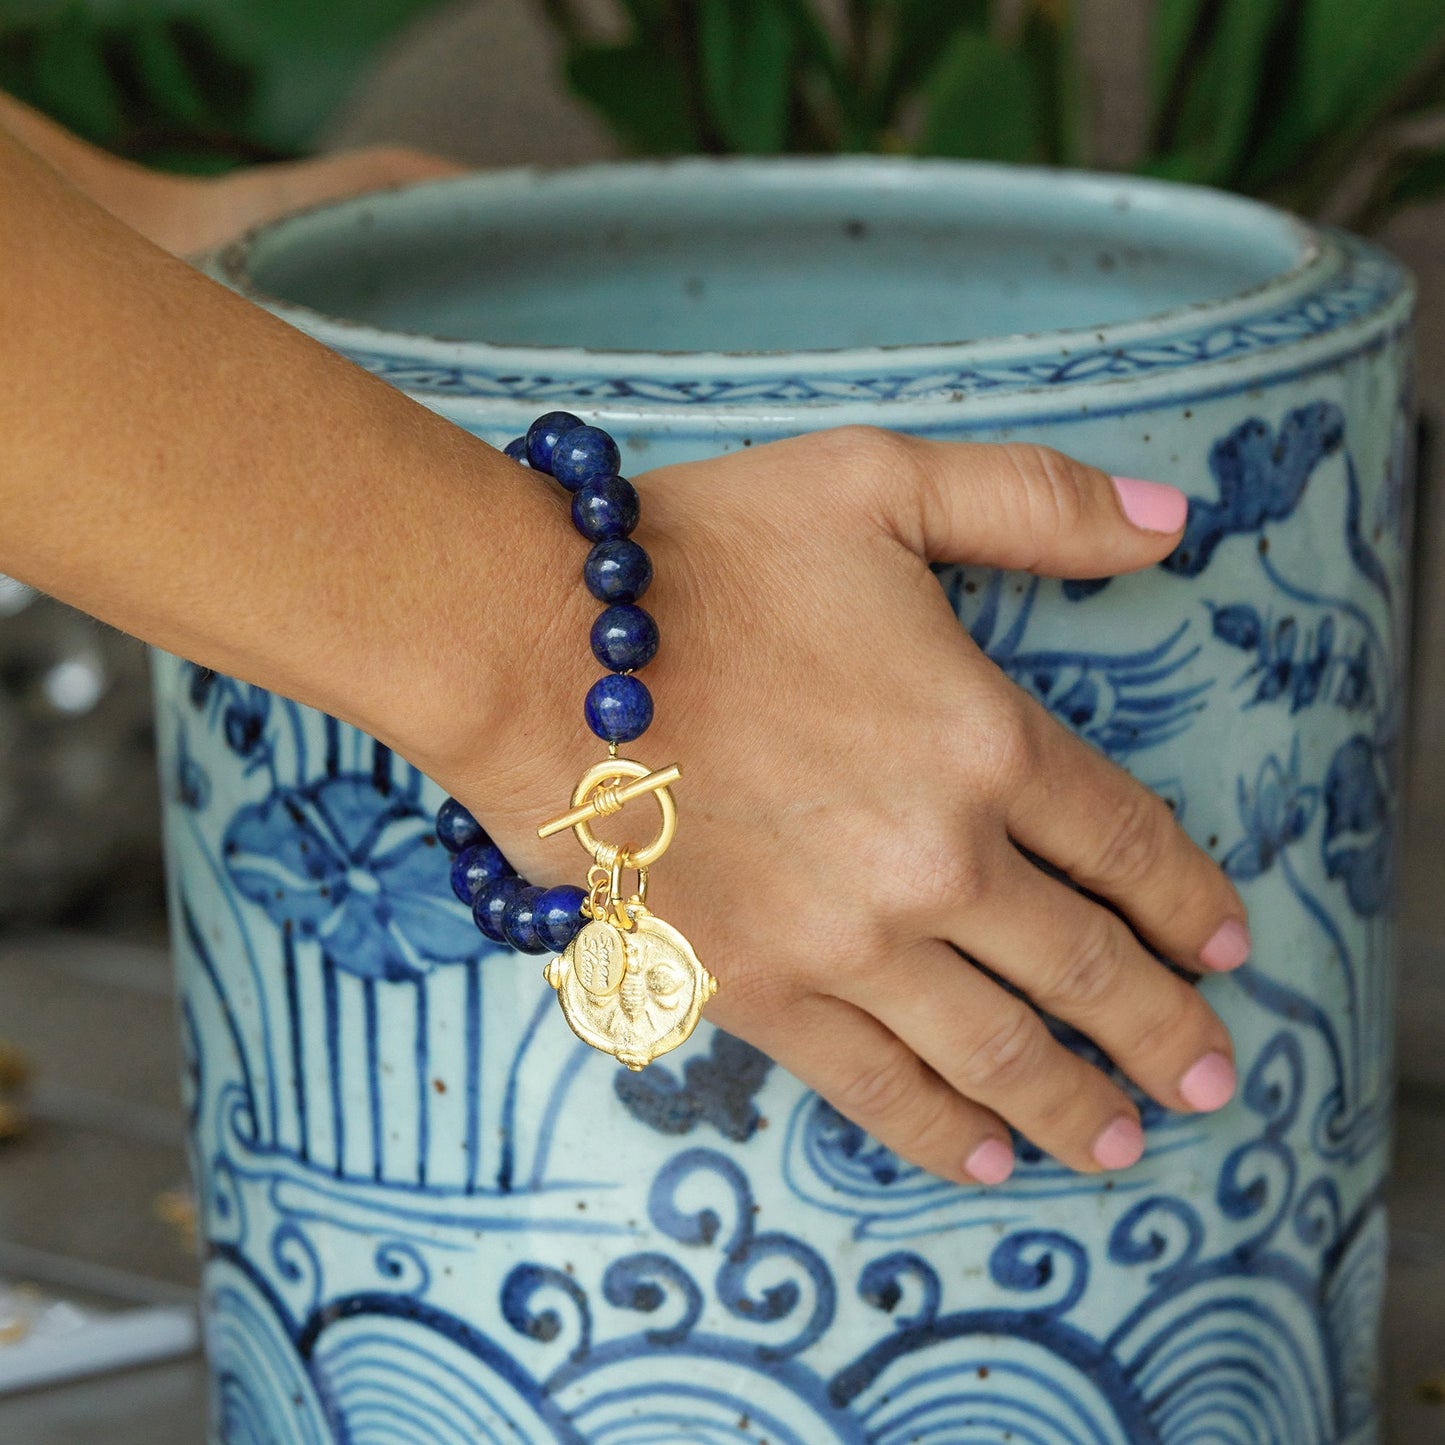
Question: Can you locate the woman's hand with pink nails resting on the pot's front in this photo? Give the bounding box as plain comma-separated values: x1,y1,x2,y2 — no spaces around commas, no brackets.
453,428,1248,1183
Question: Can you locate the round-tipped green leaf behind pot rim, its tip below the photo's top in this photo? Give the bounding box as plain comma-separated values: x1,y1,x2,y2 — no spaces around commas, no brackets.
919,32,1045,160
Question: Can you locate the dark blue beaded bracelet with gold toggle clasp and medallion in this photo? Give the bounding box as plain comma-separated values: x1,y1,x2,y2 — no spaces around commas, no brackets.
436,412,718,1069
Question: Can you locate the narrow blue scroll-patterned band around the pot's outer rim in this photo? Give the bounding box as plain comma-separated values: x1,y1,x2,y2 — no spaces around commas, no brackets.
328,236,1405,406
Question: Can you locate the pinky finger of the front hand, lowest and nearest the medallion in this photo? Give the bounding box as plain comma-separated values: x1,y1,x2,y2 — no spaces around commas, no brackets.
749,994,1014,1185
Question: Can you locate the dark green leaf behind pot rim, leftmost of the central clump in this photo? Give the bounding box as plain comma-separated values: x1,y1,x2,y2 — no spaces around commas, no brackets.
566,40,702,155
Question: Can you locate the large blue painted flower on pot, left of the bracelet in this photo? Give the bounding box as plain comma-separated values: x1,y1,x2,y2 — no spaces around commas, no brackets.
223,775,478,981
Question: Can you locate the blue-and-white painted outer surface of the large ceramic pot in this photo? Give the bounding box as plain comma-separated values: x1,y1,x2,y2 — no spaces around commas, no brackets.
156,163,1410,1445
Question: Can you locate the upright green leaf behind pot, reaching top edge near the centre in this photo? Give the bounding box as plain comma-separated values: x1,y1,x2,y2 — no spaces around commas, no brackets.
698,0,798,155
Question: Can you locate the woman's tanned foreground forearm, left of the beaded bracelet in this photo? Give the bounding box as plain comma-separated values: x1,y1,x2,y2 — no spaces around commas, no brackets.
0,130,585,786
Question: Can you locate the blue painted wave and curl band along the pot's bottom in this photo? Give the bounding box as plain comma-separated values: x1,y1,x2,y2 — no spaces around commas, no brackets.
197,1030,1384,1445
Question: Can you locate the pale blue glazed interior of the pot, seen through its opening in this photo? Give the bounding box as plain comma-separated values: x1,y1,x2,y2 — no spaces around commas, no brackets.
239,159,1306,351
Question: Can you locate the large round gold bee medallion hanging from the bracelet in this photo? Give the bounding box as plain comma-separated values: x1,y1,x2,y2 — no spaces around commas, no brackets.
546,906,718,1069
